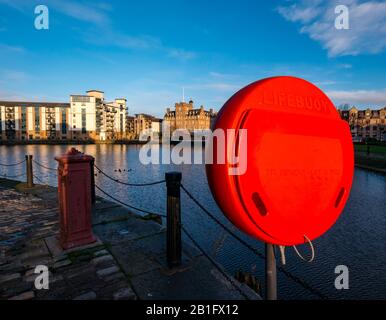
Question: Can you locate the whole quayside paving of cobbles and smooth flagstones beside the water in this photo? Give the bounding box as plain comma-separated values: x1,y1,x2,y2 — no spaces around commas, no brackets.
0,179,260,300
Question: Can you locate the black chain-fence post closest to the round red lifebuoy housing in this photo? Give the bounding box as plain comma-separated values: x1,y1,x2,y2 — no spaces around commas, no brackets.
165,172,182,268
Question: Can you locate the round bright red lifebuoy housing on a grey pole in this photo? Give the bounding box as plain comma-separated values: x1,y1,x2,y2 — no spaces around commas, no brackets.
207,77,354,246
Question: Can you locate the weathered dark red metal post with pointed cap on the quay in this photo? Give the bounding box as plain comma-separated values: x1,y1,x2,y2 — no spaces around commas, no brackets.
55,148,96,250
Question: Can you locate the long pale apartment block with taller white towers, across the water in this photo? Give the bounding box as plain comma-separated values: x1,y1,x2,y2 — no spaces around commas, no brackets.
0,90,127,142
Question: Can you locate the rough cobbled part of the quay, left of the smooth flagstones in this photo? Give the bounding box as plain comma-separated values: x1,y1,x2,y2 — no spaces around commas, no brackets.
0,182,136,300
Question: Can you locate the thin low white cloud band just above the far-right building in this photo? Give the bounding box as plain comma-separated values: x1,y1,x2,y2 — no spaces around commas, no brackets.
326,89,386,106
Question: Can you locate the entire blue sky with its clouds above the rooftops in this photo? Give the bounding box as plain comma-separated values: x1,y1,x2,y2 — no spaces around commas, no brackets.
0,0,386,116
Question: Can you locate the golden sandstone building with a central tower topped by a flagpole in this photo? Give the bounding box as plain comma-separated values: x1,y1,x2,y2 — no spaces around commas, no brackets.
164,101,217,133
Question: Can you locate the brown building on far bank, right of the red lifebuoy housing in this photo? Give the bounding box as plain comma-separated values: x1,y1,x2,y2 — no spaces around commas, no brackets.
339,107,386,142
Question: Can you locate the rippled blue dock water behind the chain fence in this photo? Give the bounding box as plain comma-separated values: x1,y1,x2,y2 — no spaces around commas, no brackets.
0,145,386,299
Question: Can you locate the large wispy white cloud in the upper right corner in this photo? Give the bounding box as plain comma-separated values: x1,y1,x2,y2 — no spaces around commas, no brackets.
277,0,386,57
